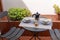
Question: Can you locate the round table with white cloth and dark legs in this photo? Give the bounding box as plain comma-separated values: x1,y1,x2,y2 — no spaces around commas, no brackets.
19,17,52,40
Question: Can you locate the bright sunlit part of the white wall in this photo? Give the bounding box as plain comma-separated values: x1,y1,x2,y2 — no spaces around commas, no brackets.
23,0,60,14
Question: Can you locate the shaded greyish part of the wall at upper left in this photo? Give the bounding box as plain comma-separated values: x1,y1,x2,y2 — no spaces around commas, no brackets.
2,0,27,11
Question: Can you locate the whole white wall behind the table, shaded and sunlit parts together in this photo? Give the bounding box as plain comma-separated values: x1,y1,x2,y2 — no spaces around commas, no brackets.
2,0,60,15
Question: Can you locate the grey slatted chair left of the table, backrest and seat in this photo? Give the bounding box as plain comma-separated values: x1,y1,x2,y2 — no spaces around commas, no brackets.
0,11,24,40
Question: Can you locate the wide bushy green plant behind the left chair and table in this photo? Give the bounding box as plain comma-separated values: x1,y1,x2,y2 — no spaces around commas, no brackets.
8,8,31,20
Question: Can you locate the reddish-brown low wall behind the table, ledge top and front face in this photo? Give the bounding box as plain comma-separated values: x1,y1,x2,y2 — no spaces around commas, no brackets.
0,15,60,36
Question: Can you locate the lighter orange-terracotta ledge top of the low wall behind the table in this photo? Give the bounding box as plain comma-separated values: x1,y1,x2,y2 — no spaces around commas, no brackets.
0,15,60,22
